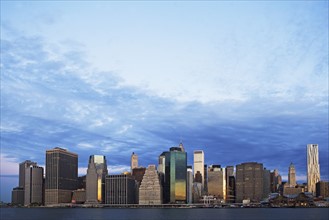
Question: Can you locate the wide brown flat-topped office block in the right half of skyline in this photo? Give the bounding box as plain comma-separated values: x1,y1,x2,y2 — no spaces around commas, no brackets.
236,162,264,202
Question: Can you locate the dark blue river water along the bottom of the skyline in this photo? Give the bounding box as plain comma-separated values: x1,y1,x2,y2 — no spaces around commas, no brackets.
0,208,329,220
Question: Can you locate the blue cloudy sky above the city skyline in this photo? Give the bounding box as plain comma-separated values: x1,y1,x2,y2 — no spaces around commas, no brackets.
0,1,329,202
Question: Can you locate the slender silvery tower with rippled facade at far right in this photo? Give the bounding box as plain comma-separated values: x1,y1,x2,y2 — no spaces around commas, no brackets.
307,144,320,195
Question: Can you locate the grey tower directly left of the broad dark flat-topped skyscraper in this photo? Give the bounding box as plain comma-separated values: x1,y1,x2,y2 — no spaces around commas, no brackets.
24,165,43,205
